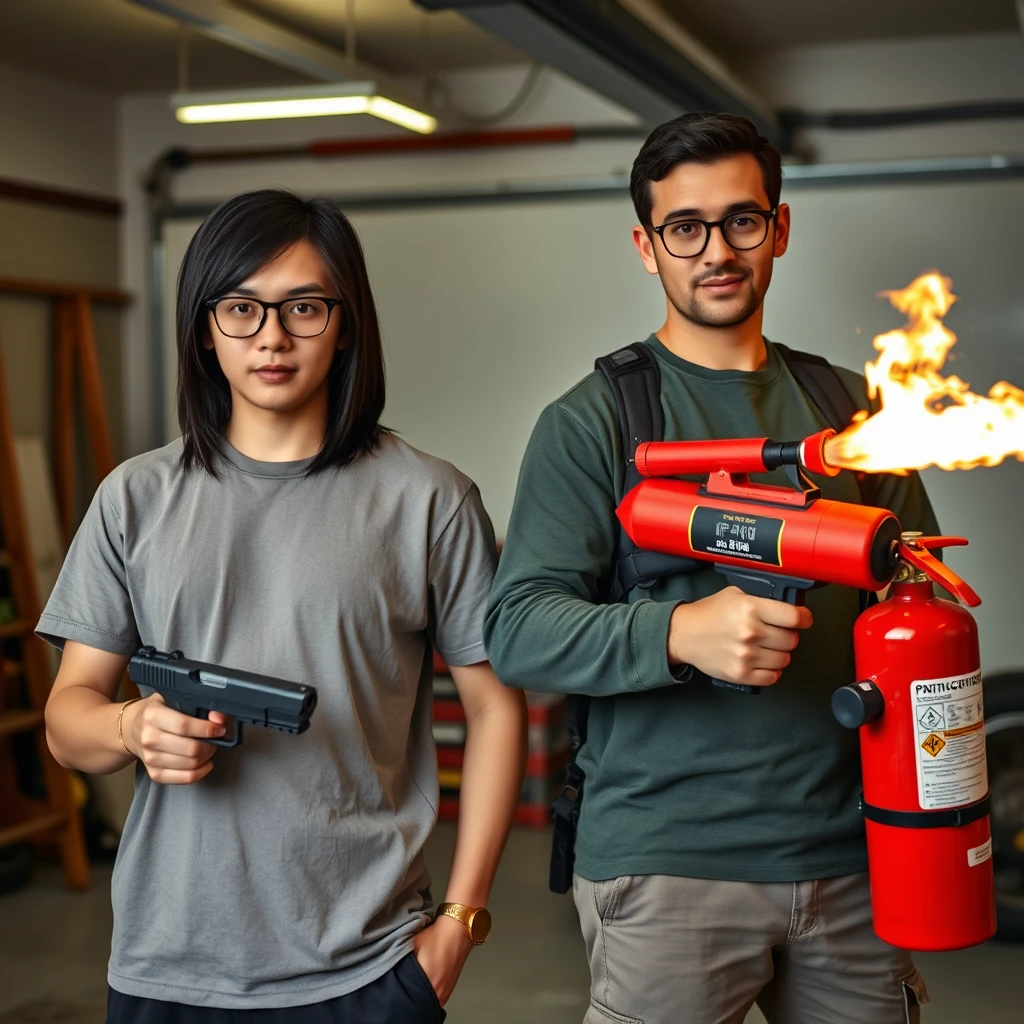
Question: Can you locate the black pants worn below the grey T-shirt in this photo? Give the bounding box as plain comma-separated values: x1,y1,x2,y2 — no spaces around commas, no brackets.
106,953,445,1024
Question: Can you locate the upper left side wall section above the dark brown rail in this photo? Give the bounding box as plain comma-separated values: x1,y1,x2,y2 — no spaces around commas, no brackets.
0,66,119,196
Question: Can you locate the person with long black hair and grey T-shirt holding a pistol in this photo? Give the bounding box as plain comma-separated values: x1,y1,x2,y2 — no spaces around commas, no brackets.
39,190,525,1024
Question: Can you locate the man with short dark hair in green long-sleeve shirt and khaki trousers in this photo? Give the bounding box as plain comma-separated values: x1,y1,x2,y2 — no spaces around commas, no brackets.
484,114,937,1024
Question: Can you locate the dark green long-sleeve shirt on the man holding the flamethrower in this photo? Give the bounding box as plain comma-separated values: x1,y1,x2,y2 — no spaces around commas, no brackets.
484,337,938,881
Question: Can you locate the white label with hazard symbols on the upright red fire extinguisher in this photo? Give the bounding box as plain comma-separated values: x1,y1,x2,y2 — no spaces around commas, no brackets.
910,672,988,811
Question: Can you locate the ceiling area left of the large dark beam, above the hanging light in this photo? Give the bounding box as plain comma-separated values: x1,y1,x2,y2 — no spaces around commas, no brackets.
0,0,526,94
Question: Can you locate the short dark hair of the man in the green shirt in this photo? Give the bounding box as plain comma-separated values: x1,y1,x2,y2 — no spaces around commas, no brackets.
630,111,782,227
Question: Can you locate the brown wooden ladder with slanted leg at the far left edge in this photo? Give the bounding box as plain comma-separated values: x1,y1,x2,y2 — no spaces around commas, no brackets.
0,325,89,889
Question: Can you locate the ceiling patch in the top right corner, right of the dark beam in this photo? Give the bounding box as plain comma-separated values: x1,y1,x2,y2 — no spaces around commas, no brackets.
657,0,1020,57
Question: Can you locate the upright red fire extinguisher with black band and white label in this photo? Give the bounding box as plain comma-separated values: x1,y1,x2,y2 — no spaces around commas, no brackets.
833,534,995,950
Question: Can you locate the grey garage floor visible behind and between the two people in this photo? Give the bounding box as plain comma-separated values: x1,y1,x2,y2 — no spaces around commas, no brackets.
0,824,1024,1024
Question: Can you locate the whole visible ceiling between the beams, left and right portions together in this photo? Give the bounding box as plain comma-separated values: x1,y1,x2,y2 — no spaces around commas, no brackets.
0,0,1020,102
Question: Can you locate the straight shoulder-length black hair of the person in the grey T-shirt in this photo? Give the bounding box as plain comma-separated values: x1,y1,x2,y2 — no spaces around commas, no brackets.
177,188,385,476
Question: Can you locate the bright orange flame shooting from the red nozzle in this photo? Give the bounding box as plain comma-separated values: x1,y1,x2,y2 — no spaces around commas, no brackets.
824,271,1024,473
